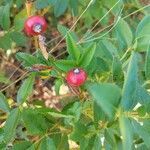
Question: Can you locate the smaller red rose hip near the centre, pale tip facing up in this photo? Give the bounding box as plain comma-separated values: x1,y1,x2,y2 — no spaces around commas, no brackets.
66,68,87,86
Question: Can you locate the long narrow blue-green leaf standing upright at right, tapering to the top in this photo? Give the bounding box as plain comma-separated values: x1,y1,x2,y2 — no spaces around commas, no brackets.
121,52,138,110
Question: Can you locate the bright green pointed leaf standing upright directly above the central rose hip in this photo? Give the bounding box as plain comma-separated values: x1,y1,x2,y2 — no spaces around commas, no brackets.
66,34,80,62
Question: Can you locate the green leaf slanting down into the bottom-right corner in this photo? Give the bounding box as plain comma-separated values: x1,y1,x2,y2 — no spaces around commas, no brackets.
132,120,150,148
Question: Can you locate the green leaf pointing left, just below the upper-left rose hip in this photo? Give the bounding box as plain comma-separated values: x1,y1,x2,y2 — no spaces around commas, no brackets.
16,52,38,67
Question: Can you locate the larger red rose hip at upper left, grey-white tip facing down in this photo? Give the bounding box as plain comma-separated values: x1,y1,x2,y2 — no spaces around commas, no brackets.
24,16,47,36
